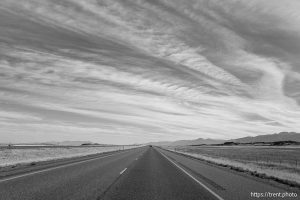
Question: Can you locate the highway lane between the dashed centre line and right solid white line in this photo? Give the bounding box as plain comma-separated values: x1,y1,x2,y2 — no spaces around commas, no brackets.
99,148,217,200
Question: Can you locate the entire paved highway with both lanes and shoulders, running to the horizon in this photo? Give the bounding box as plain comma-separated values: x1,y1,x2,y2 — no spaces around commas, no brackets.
0,147,300,200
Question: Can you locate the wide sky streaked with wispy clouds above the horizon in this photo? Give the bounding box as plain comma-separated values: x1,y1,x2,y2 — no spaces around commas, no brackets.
0,0,300,144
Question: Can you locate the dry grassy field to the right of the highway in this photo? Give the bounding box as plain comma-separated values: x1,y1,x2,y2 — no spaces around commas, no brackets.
168,146,300,186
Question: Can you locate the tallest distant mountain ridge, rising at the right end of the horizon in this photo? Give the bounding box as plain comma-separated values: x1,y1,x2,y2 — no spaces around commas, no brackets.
229,132,300,143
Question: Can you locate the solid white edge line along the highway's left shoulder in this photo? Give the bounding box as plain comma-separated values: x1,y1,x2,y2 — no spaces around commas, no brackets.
0,152,129,183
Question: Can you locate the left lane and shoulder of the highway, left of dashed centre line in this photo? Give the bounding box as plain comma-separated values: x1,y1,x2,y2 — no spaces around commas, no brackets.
0,148,146,200
